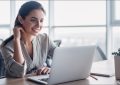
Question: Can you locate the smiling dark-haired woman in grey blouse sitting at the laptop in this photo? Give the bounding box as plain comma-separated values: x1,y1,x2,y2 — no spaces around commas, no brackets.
1,1,55,77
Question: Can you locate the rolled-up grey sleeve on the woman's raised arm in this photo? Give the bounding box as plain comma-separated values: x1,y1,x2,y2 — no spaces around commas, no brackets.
1,42,27,77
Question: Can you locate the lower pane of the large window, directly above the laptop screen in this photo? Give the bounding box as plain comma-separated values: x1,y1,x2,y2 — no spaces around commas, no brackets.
54,27,106,50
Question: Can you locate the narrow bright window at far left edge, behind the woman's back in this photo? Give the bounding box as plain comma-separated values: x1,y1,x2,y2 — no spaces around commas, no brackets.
0,0,10,39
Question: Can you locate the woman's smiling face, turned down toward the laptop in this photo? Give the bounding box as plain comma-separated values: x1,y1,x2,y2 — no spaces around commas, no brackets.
22,9,44,36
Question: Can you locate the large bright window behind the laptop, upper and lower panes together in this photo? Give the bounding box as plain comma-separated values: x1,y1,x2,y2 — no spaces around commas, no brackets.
54,0,106,59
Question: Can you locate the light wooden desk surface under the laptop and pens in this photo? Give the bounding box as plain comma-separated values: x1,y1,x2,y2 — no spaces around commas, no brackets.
0,60,117,85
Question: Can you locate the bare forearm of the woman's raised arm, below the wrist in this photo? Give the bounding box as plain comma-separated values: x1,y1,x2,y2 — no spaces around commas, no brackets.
13,39,25,64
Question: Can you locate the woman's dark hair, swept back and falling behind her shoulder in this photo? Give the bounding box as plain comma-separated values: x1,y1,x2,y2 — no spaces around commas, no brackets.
2,1,45,46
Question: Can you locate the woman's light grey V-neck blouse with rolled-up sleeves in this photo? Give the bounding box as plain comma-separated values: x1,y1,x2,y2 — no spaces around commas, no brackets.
1,33,56,77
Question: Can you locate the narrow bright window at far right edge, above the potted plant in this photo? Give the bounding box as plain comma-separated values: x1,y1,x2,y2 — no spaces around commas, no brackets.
112,0,120,52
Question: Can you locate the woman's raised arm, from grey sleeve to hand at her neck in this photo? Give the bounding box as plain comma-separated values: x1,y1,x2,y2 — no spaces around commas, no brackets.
2,28,27,77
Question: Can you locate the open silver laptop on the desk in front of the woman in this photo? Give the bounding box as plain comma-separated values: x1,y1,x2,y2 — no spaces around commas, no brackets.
27,45,96,85
